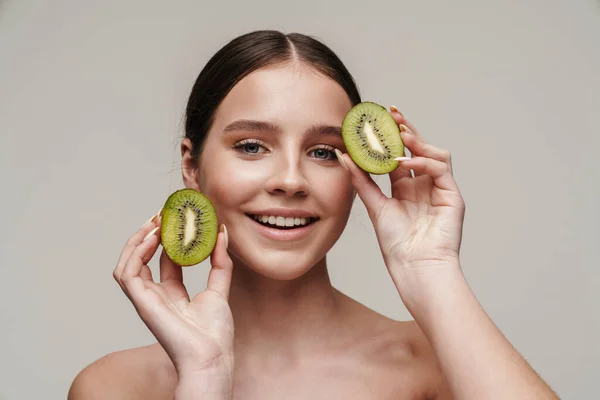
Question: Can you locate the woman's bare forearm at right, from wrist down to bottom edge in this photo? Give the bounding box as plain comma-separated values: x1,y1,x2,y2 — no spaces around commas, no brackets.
391,265,558,400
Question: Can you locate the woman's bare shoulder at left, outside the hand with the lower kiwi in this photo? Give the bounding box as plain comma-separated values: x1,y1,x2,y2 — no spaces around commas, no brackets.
68,344,177,400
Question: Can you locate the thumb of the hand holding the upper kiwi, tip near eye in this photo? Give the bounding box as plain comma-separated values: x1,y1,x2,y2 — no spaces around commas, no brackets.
335,149,387,219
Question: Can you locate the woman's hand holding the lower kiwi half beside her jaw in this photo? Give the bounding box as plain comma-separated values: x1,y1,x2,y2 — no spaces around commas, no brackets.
113,213,234,397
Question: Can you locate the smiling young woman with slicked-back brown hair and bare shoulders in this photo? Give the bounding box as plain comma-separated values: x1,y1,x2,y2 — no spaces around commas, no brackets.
69,31,557,400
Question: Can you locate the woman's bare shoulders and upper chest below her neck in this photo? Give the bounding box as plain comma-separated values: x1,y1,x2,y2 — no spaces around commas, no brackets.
69,291,451,400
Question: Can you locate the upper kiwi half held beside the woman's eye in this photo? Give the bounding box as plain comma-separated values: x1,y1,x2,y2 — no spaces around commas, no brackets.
342,101,404,175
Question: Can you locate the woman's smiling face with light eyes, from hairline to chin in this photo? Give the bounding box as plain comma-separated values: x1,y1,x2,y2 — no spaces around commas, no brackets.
188,64,354,280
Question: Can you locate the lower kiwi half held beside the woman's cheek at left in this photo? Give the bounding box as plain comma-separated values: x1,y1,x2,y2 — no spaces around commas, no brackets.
160,189,218,266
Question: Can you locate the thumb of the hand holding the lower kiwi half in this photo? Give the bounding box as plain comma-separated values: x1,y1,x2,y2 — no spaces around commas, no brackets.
206,224,233,300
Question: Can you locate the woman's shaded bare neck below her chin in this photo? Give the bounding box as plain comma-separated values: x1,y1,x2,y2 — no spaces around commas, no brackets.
229,259,345,359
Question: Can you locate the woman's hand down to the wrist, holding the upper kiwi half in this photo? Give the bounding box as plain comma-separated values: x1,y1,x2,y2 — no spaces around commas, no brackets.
336,108,465,273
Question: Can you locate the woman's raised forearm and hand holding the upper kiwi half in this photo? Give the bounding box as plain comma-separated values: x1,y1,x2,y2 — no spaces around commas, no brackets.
336,107,557,400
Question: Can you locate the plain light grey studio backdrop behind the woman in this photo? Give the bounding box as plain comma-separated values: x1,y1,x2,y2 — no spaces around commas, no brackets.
0,0,600,400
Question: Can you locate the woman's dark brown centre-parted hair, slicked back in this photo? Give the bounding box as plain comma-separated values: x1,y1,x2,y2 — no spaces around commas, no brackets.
185,30,361,159
